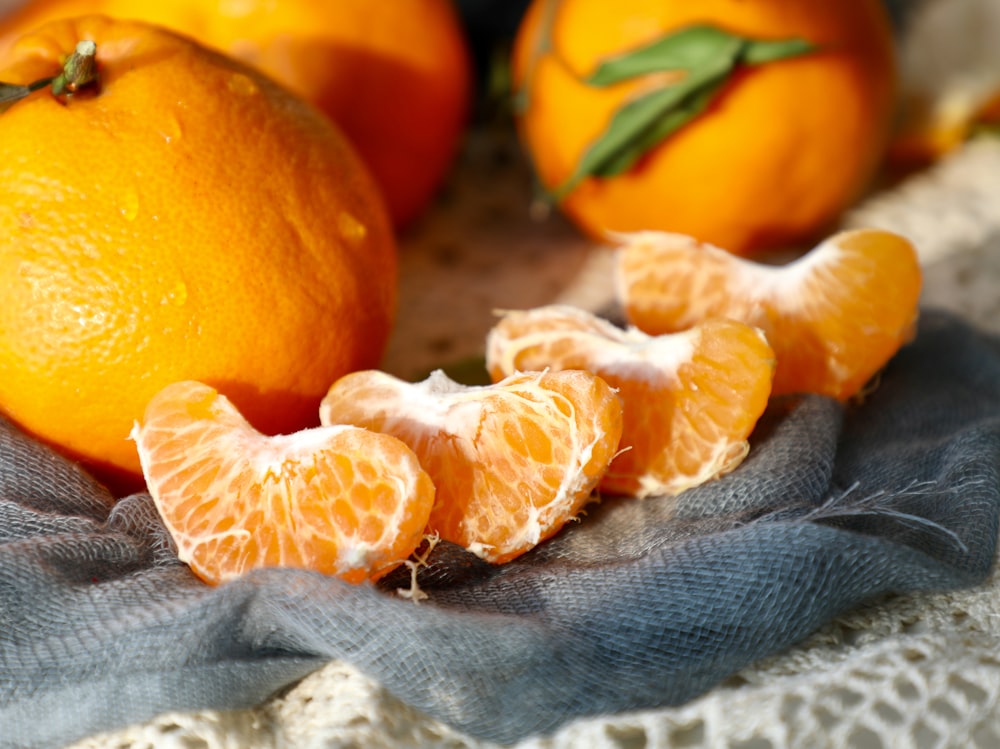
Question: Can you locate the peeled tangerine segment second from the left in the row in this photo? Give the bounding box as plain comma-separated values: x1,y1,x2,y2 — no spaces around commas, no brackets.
320,371,622,564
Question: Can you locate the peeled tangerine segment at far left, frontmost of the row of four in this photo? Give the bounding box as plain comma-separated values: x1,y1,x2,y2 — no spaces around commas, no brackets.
132,381,434,585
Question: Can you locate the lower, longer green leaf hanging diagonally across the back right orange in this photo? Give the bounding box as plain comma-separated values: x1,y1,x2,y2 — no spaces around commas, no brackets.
554,41,742,200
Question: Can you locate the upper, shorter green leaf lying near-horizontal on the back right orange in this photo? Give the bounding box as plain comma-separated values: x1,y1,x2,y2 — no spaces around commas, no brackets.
586,26,746,86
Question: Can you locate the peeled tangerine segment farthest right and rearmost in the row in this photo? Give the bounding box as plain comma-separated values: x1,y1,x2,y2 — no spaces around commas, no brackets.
617,229,921,400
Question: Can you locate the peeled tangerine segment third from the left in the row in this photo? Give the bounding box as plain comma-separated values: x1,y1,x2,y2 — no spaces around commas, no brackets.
486,305,774,497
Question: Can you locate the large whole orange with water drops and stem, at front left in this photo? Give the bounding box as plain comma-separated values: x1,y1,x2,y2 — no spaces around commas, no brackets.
0,16,397,488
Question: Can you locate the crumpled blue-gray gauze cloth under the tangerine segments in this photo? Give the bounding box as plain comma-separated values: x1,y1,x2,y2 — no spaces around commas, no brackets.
0,312,1000,747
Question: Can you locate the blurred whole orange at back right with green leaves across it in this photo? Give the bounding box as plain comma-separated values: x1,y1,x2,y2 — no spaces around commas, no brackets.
513,0,896,254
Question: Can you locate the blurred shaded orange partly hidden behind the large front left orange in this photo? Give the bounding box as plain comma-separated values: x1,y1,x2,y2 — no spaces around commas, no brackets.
0,0,471,227
